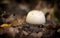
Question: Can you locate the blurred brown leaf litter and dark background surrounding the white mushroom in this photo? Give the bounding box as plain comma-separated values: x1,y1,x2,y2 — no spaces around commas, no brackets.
0,0,60,38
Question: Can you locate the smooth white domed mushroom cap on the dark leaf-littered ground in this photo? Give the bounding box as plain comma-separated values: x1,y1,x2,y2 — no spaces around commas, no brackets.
26,10,46,24
